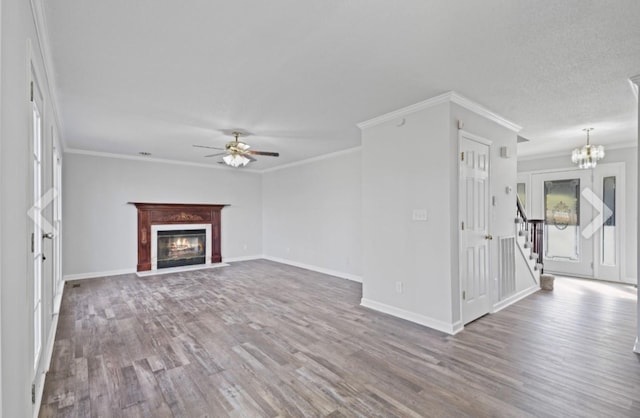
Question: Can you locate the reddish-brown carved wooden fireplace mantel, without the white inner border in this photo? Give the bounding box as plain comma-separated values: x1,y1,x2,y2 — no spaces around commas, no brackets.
129,202,229,271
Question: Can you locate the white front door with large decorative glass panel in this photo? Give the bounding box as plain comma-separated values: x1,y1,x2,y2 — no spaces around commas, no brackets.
530,170,594,277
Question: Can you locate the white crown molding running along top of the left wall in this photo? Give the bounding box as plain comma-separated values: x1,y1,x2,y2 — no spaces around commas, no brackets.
29,0,66,152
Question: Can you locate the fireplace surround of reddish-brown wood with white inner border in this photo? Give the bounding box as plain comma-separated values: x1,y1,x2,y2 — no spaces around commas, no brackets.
130,202,228,271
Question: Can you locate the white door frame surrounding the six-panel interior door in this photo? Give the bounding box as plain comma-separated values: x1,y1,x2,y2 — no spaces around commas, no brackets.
457,129,494,327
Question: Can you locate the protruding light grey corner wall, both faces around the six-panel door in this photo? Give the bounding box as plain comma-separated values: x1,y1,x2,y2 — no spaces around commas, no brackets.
362,95,516,332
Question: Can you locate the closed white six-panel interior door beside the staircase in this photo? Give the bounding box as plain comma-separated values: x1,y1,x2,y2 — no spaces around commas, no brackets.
459,131,492,324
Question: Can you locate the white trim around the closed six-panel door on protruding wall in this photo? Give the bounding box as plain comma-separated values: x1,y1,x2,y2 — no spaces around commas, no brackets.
456,129,494,324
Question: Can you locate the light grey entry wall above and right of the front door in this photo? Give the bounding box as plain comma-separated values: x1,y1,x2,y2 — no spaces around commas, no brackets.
518,148,638,281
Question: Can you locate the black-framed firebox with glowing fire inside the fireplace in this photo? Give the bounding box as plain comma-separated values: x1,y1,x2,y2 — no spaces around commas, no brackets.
158,229,207,269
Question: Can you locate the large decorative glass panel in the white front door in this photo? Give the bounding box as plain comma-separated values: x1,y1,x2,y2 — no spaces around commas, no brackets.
544,179,580,261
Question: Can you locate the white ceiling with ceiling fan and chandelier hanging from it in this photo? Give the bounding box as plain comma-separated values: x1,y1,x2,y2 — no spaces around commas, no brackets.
44,0,640,170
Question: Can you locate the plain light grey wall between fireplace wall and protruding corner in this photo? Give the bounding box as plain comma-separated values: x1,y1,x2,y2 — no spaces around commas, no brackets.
263,149,362,280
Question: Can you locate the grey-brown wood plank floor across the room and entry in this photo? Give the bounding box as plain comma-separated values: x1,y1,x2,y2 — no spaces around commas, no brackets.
40,260,640,418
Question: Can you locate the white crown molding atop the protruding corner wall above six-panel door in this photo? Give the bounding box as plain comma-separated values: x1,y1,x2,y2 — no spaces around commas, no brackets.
357,91,522,133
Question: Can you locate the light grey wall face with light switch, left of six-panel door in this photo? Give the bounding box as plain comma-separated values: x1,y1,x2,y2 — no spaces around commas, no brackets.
362,103,457,328
